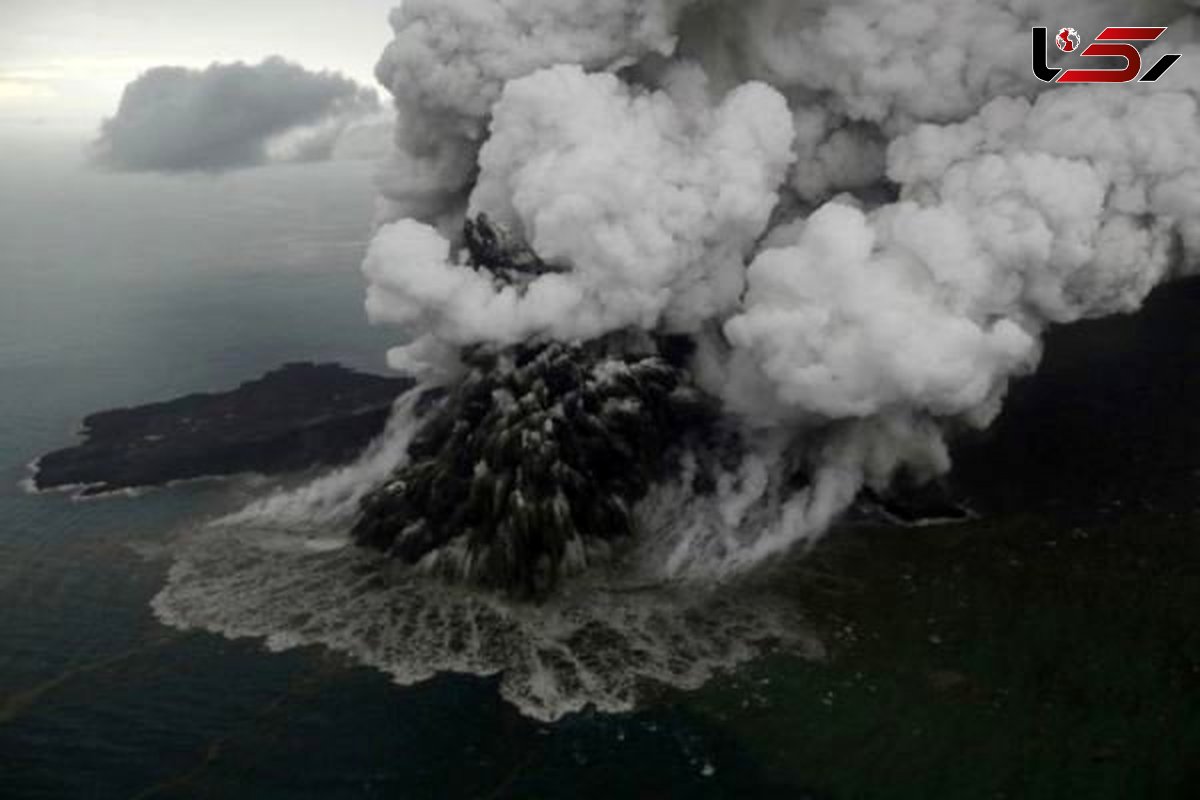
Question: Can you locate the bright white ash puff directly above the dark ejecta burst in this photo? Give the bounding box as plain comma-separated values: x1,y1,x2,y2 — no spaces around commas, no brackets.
365,67,792,369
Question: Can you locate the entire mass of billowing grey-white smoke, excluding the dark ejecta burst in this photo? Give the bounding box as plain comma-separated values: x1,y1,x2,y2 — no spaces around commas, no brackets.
365,0,1200,573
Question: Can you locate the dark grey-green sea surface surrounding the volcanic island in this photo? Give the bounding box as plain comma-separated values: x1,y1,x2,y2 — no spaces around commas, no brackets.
0,134,1200,800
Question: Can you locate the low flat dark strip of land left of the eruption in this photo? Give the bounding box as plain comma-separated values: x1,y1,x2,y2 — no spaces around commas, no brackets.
34,363,413,494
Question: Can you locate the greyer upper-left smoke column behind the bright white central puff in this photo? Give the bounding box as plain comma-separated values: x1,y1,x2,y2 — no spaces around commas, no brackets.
376,0,688,228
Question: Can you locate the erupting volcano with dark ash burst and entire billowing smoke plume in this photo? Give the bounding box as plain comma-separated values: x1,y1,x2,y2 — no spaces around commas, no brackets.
338,0,1200,596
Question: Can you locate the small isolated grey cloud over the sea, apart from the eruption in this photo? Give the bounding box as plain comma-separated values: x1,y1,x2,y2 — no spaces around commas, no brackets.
91,56,390,173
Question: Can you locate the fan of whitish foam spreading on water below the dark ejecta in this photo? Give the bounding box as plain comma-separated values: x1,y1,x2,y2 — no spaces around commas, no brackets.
152,524,823,721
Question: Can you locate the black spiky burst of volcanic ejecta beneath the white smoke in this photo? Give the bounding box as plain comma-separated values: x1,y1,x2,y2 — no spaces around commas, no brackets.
354,335,712,597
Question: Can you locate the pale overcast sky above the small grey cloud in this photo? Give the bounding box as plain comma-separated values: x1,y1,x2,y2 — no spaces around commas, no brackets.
0,0,400,128
